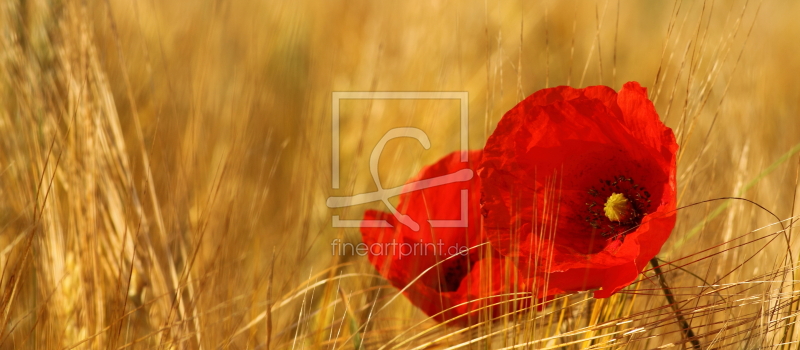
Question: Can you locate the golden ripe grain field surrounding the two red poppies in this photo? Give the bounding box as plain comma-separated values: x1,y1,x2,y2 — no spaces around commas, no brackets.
0,0,800,349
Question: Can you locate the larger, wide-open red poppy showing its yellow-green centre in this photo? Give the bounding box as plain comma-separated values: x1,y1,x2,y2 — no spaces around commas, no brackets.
479,82,678,298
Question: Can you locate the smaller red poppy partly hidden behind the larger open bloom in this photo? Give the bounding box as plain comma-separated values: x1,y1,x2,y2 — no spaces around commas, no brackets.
361,150,517,324
